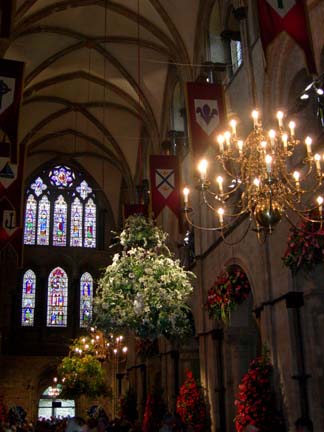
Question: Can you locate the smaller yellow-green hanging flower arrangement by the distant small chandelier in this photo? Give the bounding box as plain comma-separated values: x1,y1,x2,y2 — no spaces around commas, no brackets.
58,337,110,399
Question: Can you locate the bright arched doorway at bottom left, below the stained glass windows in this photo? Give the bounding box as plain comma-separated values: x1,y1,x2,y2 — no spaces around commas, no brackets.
38,384,75,419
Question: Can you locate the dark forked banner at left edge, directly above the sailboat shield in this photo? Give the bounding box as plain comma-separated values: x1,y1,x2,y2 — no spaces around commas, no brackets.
0,59,24,163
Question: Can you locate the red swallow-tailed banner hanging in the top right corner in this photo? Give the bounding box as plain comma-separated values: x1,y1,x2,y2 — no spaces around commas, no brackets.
257,0,316,74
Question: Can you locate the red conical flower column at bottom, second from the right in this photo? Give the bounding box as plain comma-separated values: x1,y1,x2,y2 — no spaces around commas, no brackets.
177,370,210,432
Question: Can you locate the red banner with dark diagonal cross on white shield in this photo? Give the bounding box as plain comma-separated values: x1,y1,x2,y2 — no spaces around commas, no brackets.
150,155,180,217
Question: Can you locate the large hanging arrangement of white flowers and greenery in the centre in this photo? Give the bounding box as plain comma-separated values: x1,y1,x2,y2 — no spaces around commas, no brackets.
94,216,192,339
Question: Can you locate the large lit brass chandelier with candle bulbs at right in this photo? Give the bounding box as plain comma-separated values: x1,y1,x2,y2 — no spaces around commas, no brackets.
183,110,324,240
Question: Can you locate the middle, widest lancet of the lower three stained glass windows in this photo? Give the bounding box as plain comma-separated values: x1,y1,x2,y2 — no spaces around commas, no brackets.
47,267,68,327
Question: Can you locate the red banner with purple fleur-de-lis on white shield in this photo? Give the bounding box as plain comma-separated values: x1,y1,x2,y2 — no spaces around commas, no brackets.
186,82,225,156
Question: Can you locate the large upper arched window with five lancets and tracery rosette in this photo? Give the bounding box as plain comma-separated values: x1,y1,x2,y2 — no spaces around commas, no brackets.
24,165,97,248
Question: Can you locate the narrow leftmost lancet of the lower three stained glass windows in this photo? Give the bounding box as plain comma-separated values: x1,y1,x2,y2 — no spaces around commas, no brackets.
21,270,36,327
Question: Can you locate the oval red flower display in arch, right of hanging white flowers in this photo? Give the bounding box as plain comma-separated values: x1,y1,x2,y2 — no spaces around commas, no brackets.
206,266,251,322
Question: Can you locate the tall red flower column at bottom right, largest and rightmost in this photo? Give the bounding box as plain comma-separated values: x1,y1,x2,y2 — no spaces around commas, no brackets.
234,354,283,432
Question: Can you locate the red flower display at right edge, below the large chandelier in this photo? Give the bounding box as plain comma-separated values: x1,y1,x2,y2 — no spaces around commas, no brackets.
282,221,324,274
